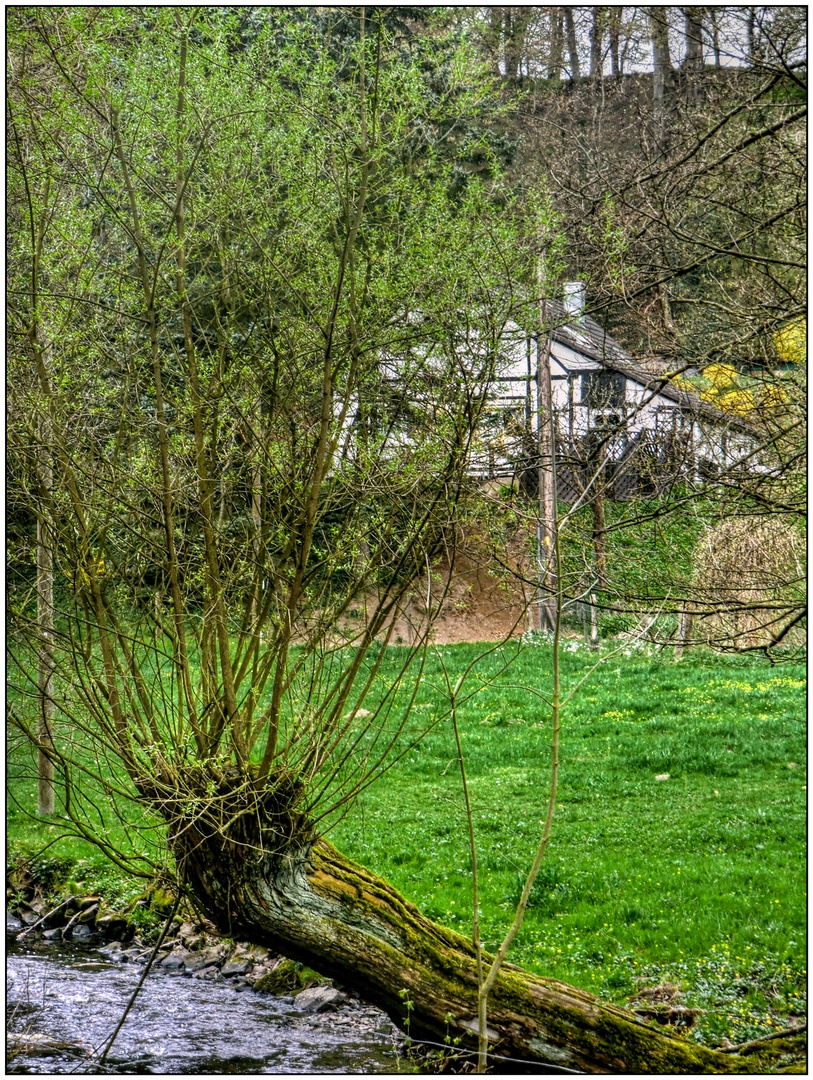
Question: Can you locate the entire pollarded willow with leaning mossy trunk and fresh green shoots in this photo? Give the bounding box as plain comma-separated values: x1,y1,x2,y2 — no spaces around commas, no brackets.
8,9,760,1071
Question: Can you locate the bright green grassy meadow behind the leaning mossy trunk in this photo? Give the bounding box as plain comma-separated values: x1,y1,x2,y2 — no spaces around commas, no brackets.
9,639,807,1042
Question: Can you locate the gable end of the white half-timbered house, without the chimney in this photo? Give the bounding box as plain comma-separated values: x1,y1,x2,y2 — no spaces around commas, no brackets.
475,291,758,502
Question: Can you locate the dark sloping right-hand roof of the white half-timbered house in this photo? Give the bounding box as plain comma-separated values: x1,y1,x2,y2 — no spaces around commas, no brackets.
546,300,756,434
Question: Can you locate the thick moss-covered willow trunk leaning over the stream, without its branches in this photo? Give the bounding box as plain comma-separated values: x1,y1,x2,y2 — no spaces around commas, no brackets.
174,824,750,1074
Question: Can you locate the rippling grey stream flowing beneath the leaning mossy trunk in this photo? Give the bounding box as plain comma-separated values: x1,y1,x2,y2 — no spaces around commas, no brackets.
6,941,397,1075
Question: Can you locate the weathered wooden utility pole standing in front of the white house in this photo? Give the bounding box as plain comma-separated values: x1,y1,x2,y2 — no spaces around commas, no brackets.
537,255,556,631
